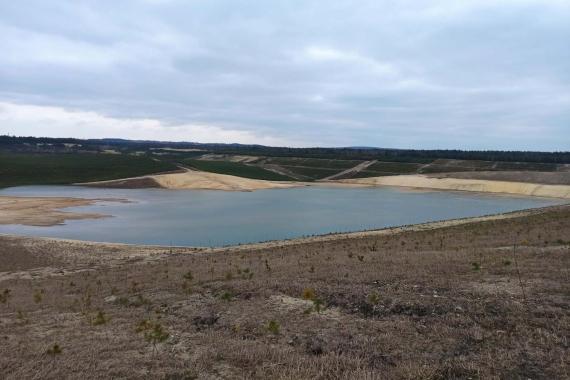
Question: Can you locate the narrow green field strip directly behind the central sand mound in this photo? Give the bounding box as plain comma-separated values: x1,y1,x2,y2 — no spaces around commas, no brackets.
183,159,293,181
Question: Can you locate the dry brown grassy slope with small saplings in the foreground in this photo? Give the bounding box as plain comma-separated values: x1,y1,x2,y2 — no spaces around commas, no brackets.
0,206,570,379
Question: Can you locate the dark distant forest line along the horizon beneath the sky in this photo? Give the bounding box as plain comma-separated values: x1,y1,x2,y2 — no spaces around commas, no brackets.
0,135,570,164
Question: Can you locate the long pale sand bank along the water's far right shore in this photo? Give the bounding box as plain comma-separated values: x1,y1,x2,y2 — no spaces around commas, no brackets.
337,175,570,199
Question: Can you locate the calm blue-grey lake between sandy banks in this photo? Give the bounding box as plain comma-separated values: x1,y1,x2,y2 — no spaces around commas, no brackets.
0,186,564,246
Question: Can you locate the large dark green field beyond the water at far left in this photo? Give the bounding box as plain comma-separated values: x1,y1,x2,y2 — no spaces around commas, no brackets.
0,153,177,188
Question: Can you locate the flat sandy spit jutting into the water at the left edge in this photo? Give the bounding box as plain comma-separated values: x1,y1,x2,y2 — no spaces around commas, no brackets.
0,196,115,226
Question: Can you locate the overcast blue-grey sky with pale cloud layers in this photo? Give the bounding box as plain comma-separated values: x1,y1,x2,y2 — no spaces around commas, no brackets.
0,0,570,150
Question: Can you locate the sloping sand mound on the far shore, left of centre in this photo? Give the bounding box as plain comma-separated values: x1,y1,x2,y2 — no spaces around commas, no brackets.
81,170,304,191
